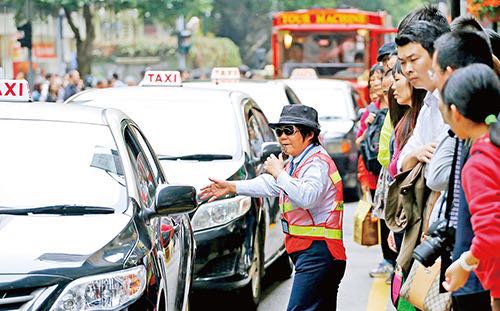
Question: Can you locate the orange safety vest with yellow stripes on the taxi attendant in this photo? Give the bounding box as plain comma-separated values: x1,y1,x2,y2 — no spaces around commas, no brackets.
280,151,346,260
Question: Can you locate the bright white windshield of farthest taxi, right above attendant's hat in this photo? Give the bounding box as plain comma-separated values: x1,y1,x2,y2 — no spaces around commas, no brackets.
293,86,354,119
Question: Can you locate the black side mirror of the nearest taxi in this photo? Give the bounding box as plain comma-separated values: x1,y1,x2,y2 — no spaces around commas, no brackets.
155,184,198,215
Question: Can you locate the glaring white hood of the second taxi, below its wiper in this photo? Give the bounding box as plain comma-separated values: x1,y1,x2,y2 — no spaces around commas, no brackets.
161,159,244,190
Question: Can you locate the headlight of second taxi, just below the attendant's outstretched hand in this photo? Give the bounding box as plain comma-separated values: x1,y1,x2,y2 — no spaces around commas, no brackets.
191,196,251,231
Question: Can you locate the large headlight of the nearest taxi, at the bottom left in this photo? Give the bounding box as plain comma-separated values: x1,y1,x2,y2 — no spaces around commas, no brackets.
50,265,146,311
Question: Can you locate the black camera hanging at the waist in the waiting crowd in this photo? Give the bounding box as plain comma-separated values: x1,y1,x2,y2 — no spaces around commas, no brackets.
413,219,455,268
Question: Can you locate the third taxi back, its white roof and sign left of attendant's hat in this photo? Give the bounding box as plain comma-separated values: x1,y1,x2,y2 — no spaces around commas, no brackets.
184,67,300,122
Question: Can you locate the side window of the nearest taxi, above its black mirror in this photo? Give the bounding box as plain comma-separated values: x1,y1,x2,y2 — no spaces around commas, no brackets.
124,127,156,207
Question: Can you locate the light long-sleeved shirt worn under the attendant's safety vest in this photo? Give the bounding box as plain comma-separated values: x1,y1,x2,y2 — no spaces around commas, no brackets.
235,146,336,221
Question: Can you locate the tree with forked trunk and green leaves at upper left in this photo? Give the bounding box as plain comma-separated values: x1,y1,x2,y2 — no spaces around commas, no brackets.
8,0,211,75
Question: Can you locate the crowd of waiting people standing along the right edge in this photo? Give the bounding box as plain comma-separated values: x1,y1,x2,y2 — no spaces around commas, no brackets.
357,6,500,310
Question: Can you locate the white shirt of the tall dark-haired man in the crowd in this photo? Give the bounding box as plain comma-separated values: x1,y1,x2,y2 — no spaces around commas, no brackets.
397,89,450,173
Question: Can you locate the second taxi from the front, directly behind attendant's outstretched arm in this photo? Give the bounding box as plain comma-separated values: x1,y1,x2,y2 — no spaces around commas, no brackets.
66,71,292,306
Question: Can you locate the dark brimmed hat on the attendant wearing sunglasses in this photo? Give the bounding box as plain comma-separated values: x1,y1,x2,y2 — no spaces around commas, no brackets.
269,105,320,132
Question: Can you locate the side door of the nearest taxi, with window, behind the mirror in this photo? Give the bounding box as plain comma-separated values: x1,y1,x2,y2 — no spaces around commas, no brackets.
125,124,185,310
